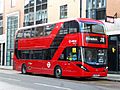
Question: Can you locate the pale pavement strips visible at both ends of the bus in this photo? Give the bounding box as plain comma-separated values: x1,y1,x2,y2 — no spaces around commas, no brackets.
0,66,120,82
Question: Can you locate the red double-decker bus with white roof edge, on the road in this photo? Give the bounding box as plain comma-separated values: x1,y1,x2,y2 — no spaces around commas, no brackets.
14,18,108,78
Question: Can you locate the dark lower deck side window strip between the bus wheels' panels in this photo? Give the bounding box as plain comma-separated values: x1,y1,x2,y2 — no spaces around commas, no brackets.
15,49,55,60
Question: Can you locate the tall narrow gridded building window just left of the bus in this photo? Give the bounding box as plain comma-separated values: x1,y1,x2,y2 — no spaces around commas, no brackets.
6,15,18,66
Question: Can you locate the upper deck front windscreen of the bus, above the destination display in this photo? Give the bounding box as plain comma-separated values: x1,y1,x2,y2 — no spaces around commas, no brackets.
81,22,105,34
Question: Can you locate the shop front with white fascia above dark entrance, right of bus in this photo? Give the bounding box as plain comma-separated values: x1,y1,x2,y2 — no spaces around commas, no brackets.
104,18,120,73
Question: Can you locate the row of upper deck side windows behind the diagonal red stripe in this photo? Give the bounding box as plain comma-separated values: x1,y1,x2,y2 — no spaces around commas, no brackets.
16,24,56,39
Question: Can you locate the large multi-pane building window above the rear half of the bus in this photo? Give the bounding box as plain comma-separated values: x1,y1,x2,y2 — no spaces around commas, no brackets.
24,0,47,26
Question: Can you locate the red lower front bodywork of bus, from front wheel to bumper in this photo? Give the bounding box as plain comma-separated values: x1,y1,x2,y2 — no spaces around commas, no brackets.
55,61,107,77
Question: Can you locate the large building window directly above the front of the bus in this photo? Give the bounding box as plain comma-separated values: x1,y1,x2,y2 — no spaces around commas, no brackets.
86,0,106,20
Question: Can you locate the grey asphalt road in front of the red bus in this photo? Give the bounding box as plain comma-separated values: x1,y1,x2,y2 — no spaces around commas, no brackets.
0,70,120,90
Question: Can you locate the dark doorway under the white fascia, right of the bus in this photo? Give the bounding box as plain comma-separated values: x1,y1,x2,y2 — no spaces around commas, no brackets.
108,35,120,72
